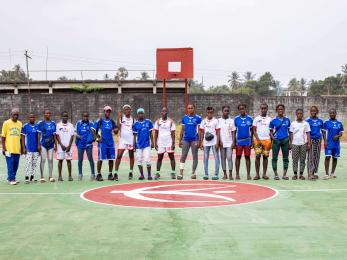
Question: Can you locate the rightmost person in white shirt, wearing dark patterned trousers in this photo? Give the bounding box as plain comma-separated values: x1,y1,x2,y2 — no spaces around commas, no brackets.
289,108,311,180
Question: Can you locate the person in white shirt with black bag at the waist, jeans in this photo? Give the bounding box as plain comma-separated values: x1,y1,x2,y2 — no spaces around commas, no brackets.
199,107,220,180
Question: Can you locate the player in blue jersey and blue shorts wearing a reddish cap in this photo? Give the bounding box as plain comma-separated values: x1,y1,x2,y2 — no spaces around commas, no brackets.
92,106,118,181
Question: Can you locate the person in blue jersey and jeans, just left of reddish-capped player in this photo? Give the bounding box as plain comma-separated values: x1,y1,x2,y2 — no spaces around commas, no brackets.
75,112,95,180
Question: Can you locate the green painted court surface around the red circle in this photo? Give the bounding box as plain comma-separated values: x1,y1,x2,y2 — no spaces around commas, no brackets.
0,146,347,259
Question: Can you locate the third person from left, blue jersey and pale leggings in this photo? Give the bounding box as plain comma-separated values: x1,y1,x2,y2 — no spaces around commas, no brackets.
37,109,57,183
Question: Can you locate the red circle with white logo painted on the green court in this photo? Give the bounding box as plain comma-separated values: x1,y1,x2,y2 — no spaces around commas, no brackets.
81,180,277,208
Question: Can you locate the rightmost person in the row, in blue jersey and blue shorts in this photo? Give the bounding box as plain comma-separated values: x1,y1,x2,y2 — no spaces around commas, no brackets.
323,108,344,179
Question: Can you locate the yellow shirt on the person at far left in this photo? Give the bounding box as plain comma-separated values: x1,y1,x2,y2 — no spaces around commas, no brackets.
1,119,22,154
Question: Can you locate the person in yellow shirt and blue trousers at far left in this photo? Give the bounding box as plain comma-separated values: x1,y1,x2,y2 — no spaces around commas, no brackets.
1,108,22,185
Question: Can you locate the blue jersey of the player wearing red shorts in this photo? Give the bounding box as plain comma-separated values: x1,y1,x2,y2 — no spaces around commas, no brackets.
234,115,253,146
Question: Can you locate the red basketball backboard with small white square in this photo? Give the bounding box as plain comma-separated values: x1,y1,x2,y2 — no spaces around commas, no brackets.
156,48,194,80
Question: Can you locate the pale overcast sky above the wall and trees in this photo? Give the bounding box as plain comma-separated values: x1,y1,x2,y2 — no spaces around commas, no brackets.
0,0,347,87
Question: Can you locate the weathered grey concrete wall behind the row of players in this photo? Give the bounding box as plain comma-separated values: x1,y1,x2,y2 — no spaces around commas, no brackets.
0,92,347,124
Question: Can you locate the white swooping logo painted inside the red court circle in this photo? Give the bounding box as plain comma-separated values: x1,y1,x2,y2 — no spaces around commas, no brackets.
110,183,236,203
